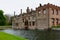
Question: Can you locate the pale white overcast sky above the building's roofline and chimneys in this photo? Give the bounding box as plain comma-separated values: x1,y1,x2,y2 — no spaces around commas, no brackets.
0,0,60,15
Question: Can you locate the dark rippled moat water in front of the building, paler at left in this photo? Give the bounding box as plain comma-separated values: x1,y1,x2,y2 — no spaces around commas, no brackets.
1,30,60,40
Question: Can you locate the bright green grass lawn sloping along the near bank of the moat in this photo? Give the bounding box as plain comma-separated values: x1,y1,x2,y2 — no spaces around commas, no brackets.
0,32,26,40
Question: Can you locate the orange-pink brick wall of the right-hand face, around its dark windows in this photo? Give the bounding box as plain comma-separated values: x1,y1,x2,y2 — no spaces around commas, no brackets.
49,8,60,27
